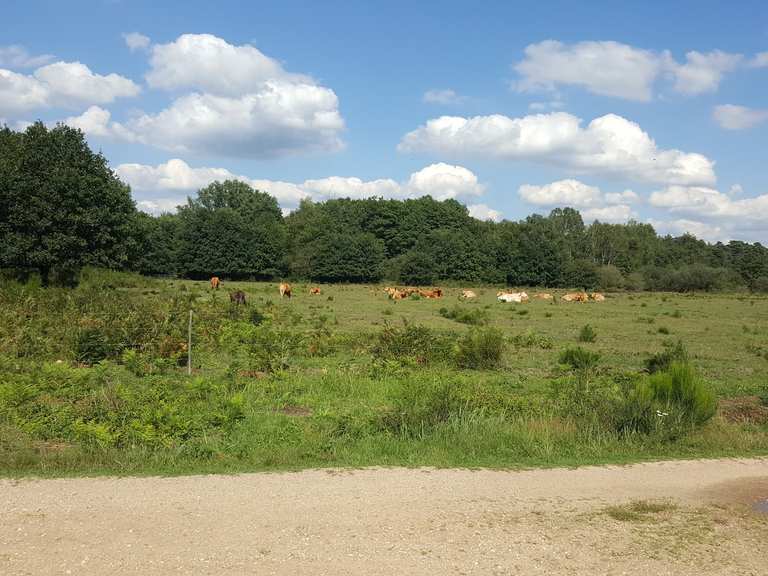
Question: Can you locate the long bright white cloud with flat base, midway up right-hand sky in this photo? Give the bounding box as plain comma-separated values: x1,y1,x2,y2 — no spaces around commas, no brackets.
398,112,715,185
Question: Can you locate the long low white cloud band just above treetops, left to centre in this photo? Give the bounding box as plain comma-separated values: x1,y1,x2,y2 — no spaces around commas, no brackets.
115,159,484,205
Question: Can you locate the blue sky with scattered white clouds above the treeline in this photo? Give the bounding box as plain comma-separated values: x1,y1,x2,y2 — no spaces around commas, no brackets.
0,0,768,243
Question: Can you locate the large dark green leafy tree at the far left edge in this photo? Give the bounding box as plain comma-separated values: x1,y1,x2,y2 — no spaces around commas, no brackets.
0,122,136,284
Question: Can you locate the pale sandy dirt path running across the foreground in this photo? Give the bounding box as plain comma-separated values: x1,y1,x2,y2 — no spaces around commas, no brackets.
0,459,768,576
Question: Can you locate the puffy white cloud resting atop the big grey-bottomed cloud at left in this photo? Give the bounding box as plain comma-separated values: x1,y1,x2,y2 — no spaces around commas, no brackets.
147,34,298,96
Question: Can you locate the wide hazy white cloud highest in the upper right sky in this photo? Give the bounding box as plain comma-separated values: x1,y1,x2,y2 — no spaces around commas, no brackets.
514,40,742,102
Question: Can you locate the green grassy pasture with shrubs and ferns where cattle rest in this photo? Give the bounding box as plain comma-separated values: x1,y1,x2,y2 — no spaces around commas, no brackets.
0,270,768,476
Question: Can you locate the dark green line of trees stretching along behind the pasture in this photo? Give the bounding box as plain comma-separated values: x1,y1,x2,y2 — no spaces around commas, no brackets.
0,123,768,292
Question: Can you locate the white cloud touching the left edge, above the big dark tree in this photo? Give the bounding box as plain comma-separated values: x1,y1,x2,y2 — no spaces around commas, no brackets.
0,62,141,114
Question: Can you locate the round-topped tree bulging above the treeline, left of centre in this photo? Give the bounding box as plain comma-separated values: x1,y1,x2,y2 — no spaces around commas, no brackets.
178,180,285,278
